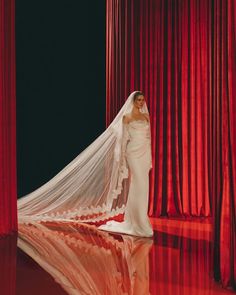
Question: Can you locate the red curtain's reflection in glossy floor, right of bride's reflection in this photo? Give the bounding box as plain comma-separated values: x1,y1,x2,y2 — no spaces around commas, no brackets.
150,232,214,295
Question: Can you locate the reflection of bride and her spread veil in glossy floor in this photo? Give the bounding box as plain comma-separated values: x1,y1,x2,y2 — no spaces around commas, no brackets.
18,222,153,295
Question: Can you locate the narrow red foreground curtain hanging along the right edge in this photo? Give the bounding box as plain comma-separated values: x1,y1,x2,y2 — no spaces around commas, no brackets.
213,0,236,289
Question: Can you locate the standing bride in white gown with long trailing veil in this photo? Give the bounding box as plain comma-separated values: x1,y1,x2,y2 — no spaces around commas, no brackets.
18,91,153,237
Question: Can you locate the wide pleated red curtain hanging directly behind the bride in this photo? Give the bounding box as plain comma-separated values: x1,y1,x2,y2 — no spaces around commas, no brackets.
106,0,213,216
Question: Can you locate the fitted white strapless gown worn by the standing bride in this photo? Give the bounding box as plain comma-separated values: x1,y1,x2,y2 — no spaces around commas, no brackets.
98,120,153,237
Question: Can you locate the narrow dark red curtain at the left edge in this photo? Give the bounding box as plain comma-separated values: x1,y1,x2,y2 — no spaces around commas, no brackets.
0,0,17,234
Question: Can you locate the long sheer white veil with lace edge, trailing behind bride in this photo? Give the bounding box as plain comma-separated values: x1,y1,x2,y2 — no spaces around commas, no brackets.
18,91,148,223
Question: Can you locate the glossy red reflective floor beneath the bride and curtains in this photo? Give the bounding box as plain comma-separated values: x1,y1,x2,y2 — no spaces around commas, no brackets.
0,218,233,295
